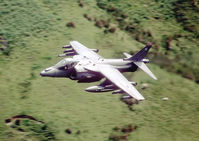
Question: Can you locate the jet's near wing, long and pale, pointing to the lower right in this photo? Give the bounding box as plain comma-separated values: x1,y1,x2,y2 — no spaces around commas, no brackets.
85,64,144,100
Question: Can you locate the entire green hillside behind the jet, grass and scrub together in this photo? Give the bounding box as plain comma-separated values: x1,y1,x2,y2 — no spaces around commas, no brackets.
0,0,199,141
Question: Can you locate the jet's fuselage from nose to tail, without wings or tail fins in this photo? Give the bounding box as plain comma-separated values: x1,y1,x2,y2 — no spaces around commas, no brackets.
40,55,138,83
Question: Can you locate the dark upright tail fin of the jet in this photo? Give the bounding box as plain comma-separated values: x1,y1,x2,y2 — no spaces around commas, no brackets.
128,43,152,62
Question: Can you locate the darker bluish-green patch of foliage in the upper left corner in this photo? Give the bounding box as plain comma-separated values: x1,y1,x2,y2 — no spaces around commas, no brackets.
0,0,52,55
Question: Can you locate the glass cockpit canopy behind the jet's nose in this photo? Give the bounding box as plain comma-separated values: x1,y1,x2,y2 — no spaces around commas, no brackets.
55,58,76,70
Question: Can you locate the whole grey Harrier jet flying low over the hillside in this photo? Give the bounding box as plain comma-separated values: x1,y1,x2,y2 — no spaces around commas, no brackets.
40,41,157,101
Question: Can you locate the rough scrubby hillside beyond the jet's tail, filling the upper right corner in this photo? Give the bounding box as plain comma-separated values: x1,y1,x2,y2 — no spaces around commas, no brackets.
97,0,199,82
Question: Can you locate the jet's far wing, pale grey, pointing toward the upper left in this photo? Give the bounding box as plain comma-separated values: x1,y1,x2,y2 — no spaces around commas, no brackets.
70,41,102,60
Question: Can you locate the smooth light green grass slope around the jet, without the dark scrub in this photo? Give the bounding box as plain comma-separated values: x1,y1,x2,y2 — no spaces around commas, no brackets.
0,0,199,141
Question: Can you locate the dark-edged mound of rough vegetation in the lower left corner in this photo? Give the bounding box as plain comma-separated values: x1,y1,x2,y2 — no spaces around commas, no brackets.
6,115,55,141
